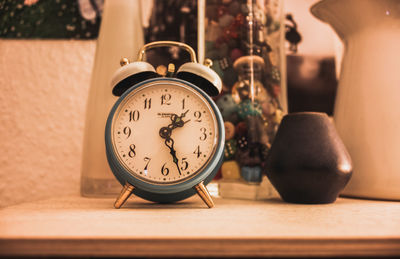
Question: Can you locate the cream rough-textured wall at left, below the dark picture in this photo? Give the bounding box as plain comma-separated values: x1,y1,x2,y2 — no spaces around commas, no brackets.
0,40,95,207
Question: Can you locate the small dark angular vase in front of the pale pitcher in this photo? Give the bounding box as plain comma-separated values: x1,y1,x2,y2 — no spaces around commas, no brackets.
265,112,353,204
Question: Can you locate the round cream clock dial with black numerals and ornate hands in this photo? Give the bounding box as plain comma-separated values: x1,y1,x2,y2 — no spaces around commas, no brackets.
111,80,219,185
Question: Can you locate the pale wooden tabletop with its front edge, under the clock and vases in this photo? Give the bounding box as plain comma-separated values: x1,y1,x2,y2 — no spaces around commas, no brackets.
0,196,400,256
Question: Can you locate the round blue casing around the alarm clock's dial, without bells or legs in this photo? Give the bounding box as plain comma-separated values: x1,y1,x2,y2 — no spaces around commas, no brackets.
105,77,225,203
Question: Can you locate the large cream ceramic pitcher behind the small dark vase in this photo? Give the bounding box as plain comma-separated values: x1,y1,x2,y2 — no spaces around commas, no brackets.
311,0,400,200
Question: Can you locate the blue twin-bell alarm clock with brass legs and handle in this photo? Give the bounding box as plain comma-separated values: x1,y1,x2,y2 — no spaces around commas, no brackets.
105,41,225,208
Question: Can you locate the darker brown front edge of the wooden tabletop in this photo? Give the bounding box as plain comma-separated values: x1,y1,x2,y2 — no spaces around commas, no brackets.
0,237,400,257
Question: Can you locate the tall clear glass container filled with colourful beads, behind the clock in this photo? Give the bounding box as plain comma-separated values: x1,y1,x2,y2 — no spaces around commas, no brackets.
199,0,287,199
